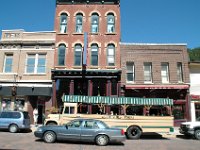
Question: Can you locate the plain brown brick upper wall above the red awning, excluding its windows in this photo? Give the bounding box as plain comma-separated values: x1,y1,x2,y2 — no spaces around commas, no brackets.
120,43,190,85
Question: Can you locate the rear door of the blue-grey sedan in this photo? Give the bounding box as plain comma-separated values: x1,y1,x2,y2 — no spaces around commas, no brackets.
81,120,100,141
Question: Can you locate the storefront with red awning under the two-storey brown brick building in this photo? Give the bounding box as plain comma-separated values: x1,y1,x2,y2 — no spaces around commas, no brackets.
124,84,190,126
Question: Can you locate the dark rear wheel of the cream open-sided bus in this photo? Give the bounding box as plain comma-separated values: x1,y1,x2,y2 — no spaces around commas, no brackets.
127,126,142,139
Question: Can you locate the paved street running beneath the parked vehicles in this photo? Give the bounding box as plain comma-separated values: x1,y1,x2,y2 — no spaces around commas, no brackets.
0,127,200,150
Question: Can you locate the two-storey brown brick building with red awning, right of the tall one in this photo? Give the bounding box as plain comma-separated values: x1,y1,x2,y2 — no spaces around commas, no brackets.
120,43,190,125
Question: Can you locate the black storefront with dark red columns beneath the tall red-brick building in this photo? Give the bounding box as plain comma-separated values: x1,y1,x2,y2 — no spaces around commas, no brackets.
52,69,121,110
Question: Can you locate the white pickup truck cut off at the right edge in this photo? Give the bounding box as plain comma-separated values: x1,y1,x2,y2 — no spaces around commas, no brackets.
179,117,200,140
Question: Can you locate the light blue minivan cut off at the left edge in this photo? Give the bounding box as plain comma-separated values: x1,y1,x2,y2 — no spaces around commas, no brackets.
0,111,30,133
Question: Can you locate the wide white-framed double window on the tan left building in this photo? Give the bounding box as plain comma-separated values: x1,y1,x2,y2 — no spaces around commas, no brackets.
26,54,46,74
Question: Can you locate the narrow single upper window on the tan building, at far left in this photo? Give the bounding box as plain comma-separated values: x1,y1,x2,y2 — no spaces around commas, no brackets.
3,54,13,73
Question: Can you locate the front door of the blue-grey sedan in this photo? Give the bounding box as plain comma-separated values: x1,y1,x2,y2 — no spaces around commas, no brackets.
59,120,82,141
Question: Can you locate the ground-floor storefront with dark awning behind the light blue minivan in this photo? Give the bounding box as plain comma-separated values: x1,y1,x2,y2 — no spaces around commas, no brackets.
0,84,52,123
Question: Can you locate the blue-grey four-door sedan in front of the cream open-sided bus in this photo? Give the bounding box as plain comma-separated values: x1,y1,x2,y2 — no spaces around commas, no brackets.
34,119,126,146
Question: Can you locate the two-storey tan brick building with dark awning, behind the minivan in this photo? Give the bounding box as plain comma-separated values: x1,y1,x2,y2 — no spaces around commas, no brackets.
0,30,55,123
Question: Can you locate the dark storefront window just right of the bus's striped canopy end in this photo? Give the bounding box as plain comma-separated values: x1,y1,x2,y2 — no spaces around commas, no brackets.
173,105,185,119
